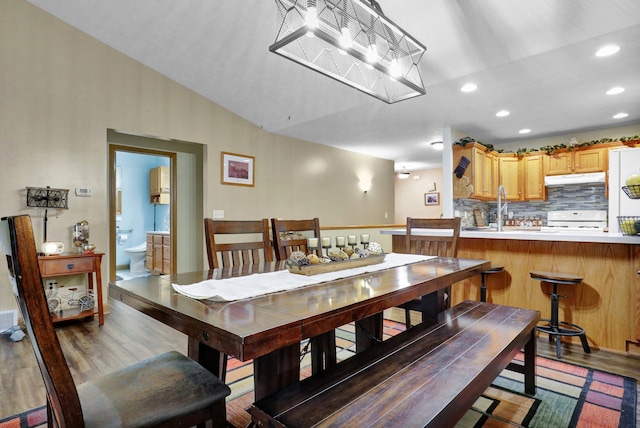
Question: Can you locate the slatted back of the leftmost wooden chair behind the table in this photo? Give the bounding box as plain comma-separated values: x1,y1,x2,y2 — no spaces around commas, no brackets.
204,218,273,269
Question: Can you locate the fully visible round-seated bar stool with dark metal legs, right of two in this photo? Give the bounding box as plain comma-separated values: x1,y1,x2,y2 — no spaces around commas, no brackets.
529,271,591,359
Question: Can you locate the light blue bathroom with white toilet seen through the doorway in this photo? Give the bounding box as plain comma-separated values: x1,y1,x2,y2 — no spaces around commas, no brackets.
116,151,170,279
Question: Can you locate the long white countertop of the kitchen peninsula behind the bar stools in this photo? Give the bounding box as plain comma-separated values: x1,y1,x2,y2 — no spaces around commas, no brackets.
380,229,640,245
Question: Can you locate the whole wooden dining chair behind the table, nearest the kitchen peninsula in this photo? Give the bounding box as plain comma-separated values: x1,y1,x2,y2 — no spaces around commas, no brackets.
399,217,461,328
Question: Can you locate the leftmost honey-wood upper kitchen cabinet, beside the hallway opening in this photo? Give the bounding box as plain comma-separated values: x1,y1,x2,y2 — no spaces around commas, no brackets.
453,143,498,200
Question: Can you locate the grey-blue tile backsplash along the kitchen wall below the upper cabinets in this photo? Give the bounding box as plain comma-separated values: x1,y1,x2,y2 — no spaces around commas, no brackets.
453,184,609,227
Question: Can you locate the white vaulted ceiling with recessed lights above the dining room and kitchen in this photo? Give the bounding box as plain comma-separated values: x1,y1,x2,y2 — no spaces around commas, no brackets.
28,0,640,170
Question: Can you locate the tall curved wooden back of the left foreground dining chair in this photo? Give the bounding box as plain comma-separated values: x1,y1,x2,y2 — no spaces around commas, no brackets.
0,215,84,427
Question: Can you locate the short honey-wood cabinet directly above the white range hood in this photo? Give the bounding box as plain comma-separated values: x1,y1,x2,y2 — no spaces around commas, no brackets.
546,148,608,175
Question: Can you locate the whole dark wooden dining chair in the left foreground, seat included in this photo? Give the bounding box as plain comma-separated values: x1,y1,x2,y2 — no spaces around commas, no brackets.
0,215,231,428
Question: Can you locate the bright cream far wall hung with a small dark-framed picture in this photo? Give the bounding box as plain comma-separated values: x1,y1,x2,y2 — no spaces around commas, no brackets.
395,168,443,224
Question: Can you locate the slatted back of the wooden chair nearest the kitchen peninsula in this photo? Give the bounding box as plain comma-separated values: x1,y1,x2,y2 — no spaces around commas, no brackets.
405,217,461,257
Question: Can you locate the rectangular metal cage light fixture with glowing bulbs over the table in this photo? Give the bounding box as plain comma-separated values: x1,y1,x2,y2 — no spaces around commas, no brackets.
269,0,426,104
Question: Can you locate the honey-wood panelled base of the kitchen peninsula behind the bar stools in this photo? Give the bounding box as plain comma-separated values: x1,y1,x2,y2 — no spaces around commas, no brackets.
451,238,640,355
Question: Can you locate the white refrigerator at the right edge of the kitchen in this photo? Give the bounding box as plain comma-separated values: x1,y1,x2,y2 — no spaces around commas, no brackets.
609,148,640,233
